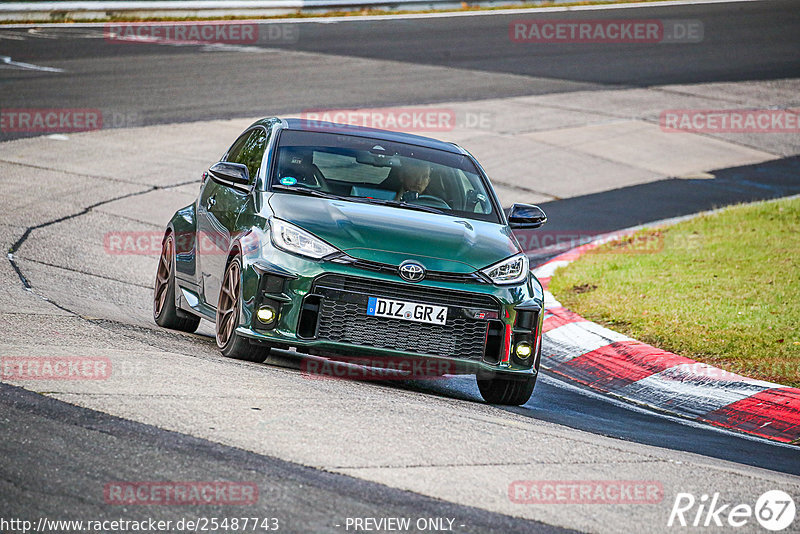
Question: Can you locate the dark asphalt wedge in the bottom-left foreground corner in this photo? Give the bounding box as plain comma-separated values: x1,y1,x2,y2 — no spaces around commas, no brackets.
0,384,571,533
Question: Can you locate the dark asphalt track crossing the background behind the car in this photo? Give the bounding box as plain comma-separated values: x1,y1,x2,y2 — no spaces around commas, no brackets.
0,0,800,138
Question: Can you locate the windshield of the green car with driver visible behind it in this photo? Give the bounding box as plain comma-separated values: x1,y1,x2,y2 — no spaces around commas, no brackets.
270,130,500,222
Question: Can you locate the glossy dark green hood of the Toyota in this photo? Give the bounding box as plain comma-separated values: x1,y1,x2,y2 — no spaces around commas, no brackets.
269,193,519,273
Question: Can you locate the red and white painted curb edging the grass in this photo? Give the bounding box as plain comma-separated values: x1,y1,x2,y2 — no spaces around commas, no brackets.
533,237,800,444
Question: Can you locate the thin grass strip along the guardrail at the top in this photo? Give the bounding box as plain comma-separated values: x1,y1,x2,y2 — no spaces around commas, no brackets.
0,0,688,25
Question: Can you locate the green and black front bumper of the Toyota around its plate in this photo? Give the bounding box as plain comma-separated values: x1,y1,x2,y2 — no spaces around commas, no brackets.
237,241,543,375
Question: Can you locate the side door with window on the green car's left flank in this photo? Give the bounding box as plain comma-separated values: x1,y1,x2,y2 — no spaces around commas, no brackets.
197,126,269,307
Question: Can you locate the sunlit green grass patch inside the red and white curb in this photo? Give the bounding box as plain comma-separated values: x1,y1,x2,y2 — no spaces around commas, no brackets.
551,199,800,387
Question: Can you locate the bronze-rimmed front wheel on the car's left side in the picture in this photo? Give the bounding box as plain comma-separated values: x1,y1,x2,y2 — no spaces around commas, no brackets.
214,257,270,363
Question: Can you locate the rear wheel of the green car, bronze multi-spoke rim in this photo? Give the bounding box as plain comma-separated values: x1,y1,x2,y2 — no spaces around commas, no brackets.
153,234,200,333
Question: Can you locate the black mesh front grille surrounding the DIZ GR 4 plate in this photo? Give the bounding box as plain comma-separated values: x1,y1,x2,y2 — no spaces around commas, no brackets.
313,275,500,361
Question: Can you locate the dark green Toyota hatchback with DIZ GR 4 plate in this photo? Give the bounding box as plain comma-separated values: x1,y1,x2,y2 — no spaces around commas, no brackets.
153,118,546,404
